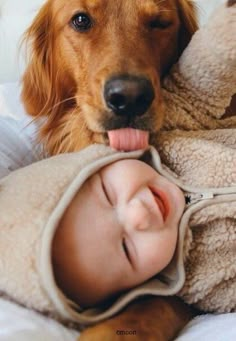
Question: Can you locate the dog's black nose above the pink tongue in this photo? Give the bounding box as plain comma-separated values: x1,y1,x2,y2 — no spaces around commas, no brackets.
104,75,155,116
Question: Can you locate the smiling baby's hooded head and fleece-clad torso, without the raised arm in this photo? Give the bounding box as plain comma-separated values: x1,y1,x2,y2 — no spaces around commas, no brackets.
0,135,236,325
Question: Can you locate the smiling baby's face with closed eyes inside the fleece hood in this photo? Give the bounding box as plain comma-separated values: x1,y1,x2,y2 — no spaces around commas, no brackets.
58,160,184,306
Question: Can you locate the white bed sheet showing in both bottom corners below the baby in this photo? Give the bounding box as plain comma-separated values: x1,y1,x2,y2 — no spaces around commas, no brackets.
0,298,236,341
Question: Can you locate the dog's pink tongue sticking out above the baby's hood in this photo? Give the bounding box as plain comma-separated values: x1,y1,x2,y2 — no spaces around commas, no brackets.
108,128,149,152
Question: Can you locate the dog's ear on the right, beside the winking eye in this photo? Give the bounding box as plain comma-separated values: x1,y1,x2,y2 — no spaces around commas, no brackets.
177,0,198,56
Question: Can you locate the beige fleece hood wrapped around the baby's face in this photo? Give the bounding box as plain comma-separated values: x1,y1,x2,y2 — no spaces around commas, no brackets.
0,145,192,324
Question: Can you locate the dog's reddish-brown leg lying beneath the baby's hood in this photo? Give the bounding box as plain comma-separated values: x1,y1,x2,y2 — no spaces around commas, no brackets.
78,297,197,341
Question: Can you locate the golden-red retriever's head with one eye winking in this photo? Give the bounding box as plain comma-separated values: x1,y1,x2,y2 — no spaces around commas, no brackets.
22,0,197,154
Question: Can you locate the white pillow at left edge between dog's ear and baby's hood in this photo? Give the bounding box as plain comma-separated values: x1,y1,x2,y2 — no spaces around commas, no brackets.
0,83,43,178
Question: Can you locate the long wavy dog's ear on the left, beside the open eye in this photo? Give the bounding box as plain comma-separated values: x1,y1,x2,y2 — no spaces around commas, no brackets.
21,1,73,120
